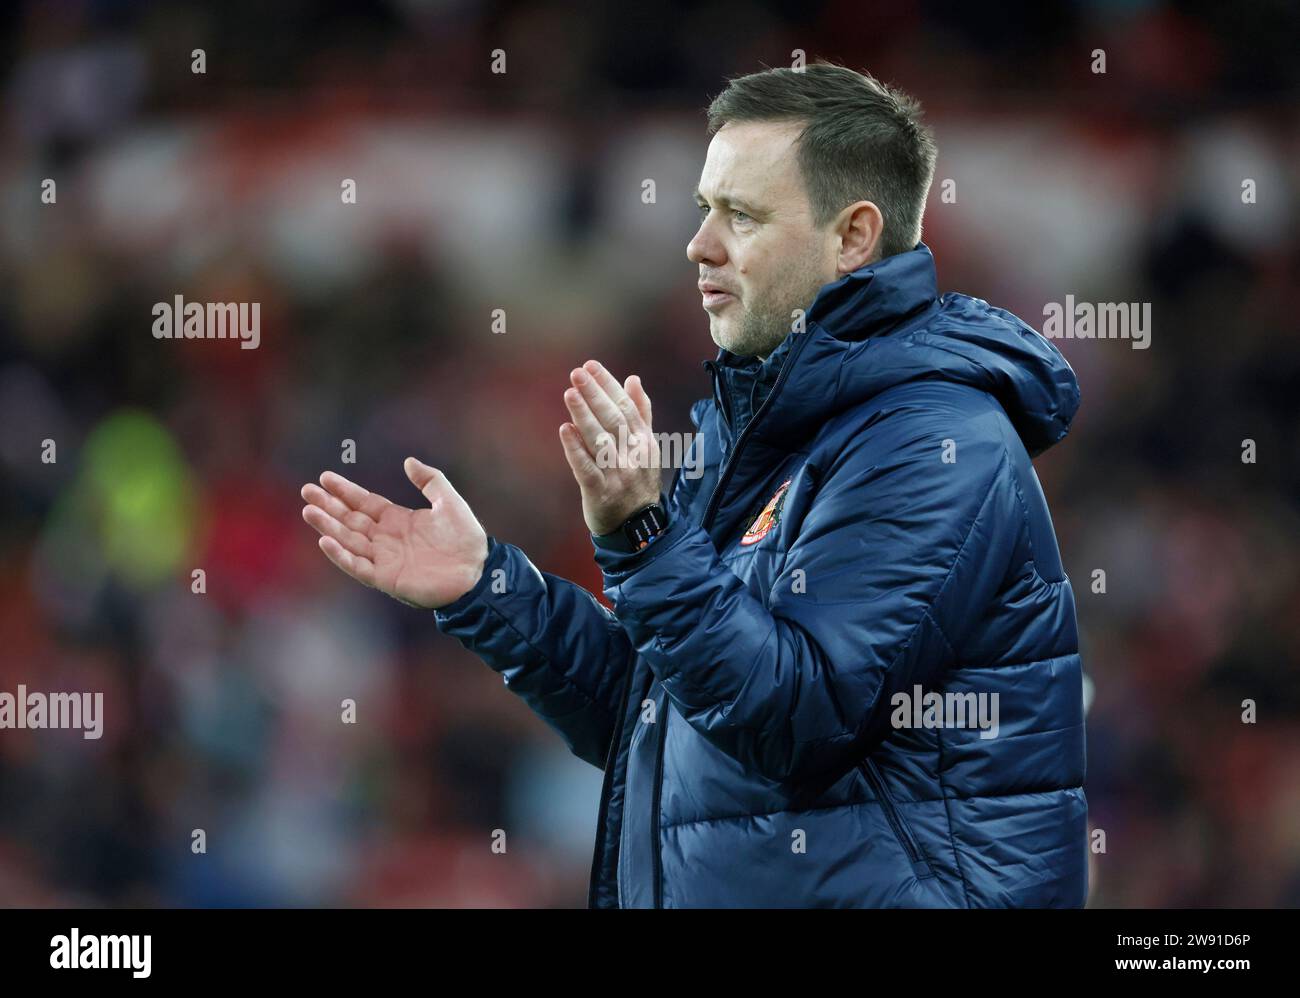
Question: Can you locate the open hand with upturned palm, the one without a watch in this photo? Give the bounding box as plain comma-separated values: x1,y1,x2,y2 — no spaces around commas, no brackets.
302,457,488,608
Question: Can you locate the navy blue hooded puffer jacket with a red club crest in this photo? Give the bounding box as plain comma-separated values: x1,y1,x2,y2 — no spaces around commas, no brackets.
436,243,1087,907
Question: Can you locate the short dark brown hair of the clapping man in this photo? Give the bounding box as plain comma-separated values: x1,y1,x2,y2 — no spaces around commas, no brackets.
709,61,937,256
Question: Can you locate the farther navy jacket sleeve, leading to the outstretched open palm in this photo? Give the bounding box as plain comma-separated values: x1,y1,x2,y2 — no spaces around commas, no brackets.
434,535,633,769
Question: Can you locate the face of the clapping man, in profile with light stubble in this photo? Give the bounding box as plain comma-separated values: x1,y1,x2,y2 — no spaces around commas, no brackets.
686,122,839,359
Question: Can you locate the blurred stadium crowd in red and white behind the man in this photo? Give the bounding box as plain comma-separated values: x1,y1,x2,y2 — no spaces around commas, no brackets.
0,0,1300,907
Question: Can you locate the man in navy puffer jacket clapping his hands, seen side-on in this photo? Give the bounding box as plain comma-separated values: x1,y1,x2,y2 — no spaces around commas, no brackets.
303,64,1087,907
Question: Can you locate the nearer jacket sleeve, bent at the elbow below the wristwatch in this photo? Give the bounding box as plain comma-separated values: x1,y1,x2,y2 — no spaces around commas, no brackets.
597,396,1022,784
